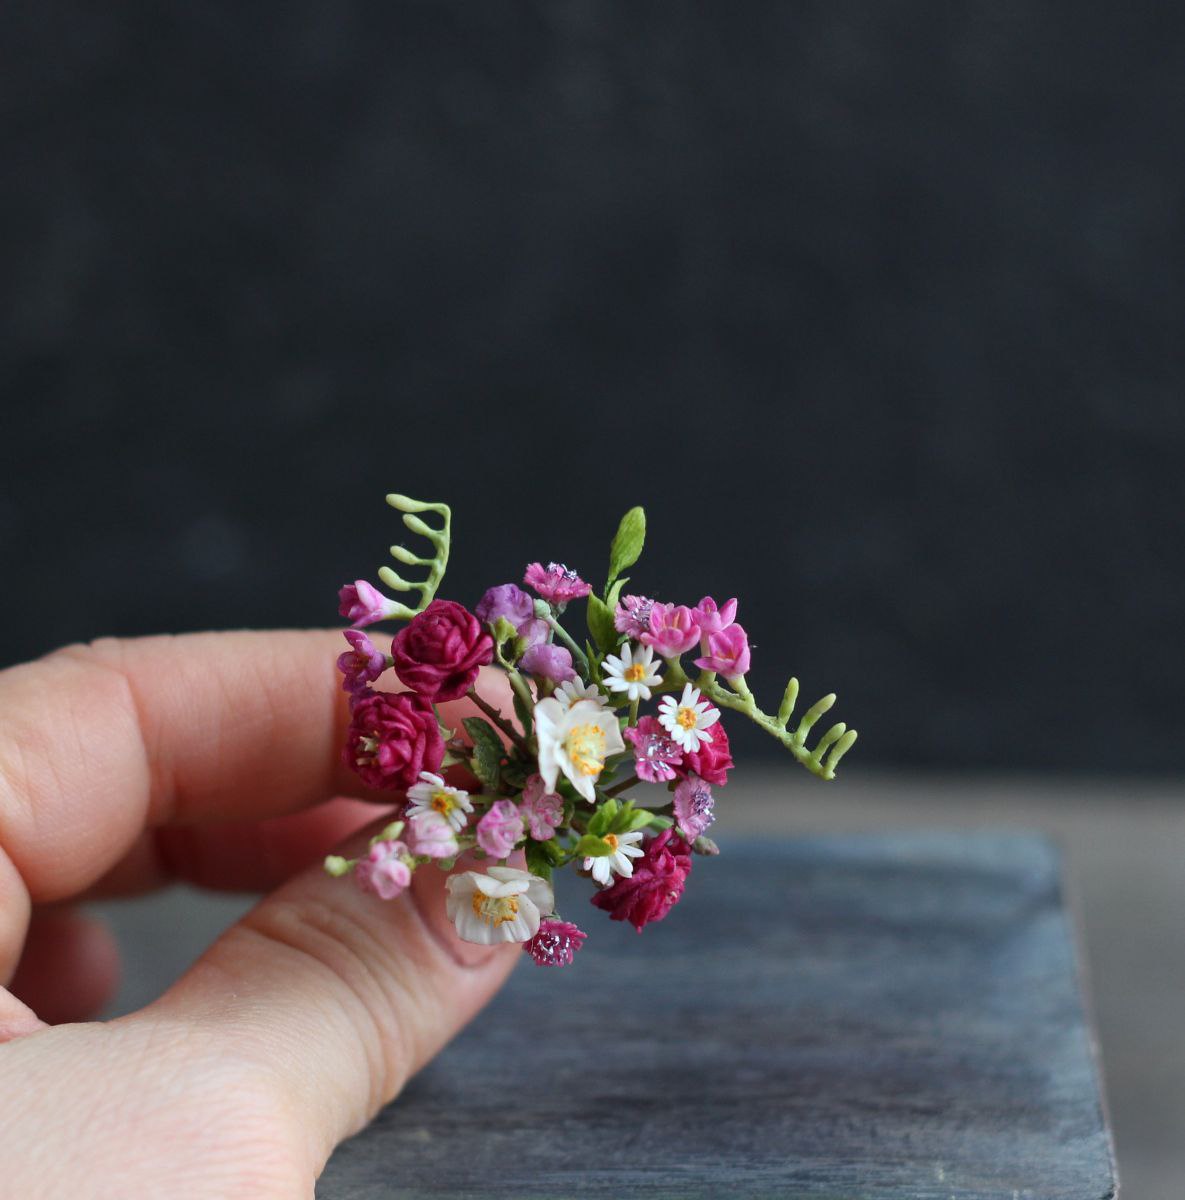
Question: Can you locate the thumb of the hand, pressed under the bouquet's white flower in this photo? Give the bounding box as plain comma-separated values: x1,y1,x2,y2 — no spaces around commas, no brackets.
143,818,522,1169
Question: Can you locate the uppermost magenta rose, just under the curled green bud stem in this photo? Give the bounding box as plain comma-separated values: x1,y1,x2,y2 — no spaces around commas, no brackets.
391,600,494,703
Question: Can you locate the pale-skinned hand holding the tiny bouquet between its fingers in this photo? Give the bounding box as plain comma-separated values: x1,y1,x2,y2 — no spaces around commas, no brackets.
0,631,523,1200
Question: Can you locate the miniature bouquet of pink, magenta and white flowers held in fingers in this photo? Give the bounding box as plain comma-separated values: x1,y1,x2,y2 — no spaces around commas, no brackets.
325,496,856,966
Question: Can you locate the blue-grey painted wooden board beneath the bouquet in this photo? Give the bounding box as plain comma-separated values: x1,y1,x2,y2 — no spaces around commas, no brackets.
318,833,1114,1200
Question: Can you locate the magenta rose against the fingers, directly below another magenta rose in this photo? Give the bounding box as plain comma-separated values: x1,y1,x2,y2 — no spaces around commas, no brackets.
342,689,444,788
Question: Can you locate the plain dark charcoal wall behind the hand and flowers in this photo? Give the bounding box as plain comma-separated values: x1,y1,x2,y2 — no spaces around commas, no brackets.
0,0,1185,770
